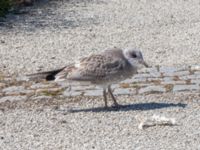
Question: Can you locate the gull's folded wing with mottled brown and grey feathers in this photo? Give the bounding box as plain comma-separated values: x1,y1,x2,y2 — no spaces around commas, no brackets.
55,54,125,81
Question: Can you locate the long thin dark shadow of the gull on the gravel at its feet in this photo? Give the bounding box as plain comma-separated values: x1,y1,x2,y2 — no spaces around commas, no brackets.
69,102,187,113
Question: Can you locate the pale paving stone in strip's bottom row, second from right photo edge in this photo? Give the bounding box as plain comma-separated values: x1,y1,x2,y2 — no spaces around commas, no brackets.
139,86,166,94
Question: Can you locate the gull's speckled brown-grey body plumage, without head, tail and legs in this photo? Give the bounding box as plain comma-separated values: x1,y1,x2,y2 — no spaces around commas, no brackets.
56,49,133,84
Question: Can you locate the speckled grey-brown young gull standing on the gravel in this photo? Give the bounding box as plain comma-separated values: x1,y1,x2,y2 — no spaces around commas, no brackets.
31,48,148,107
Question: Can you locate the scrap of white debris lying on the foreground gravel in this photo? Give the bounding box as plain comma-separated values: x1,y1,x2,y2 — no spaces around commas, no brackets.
136,114,177,130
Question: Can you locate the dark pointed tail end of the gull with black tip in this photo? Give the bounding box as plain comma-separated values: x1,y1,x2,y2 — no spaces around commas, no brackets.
27,67,65,81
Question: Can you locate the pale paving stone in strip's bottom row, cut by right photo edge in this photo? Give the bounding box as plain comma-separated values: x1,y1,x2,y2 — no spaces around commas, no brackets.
173,85,200,92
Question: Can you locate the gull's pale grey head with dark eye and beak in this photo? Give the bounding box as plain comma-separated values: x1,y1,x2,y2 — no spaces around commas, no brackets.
123,49,148,68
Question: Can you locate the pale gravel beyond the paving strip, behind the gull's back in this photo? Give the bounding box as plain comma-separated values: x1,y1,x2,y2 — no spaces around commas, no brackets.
0,0,200,73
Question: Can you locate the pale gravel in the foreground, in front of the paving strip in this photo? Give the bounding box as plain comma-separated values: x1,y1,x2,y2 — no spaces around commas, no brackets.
0,93,200,150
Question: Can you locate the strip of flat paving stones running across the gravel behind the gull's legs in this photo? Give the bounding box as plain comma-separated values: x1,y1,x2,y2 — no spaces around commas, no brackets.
0,65,200,102
